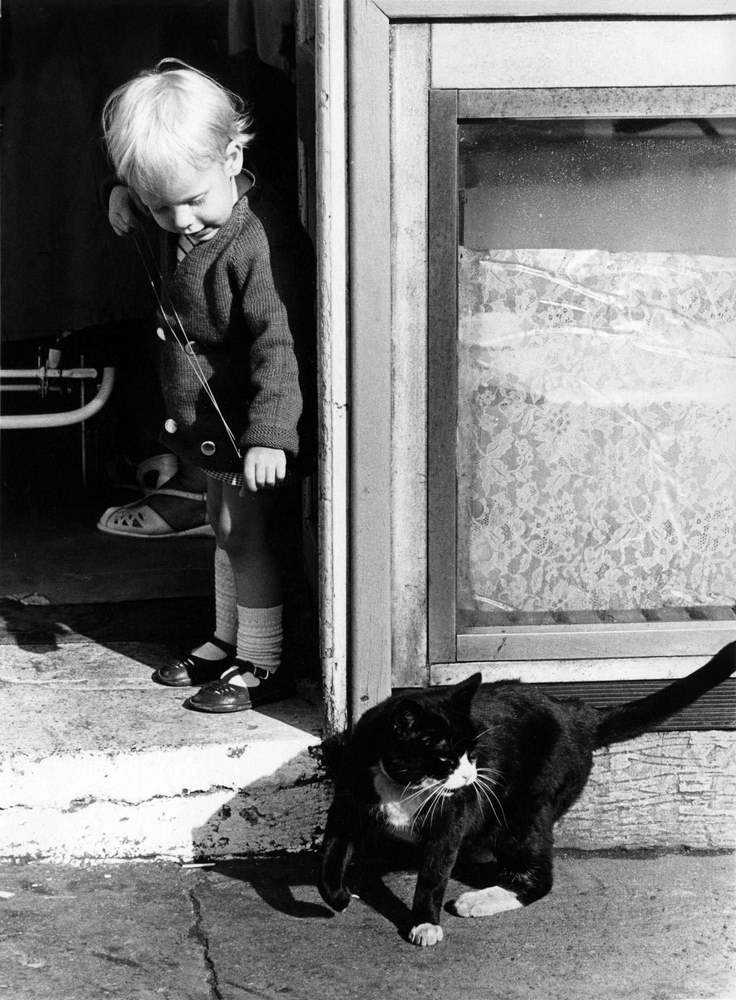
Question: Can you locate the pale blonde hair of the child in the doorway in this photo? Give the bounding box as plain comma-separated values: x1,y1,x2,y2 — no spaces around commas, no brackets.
102,59,253,194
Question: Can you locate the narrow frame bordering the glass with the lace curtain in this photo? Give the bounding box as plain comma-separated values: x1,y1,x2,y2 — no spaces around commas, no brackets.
427,86,736,664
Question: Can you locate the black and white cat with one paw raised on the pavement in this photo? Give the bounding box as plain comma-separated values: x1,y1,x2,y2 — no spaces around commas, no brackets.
320,643,736,946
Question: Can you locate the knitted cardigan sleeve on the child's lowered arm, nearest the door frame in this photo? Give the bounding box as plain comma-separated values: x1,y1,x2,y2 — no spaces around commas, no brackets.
240,226,302,455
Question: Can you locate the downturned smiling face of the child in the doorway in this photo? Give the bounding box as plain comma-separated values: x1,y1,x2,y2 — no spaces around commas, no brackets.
138,146,242,236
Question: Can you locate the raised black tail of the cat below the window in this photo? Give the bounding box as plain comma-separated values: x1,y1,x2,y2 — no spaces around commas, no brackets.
596,642,736,747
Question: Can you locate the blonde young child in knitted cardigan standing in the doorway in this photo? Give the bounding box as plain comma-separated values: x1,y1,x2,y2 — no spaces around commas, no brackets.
103,59,313,712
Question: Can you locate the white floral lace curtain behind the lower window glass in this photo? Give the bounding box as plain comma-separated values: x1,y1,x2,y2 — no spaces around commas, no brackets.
457,248,736,612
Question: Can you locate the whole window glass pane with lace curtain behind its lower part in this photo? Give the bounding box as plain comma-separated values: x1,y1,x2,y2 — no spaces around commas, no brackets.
457,119,736,628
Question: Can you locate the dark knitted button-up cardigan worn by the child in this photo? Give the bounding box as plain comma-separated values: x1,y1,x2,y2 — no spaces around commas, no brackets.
158,180,313,472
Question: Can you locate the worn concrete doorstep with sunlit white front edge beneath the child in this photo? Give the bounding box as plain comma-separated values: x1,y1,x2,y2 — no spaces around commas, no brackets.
0,642,327,862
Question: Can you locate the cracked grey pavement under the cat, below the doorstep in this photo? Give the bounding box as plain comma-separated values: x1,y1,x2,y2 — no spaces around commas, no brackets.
0,852,736,1000
